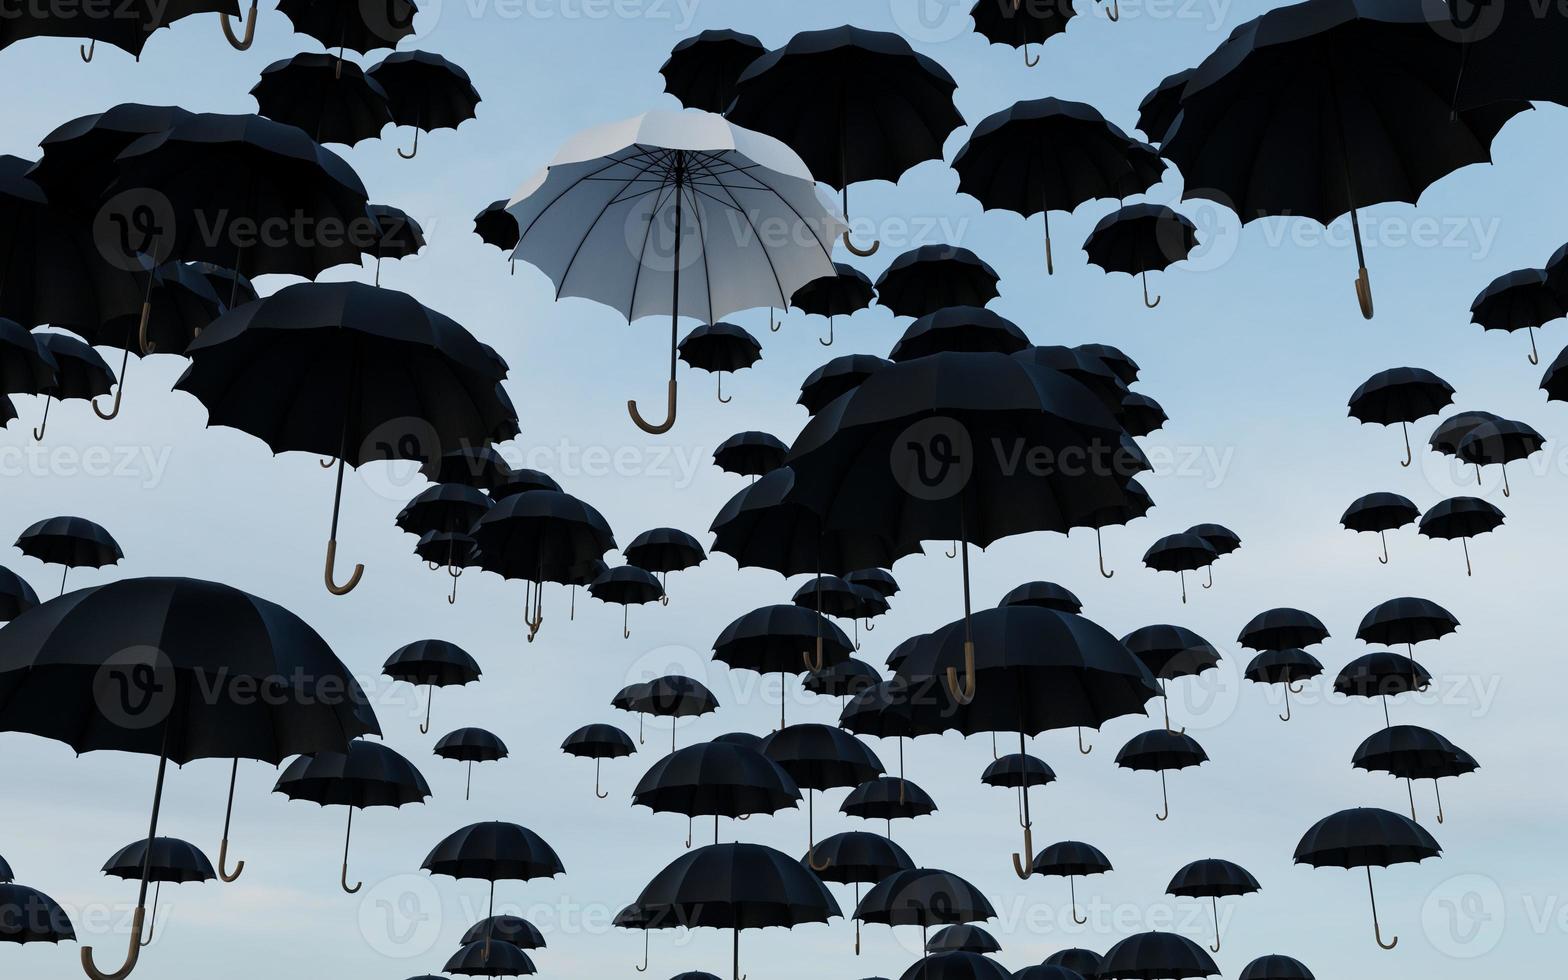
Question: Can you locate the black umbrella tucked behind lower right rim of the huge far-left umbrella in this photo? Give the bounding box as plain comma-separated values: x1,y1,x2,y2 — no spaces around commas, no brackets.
273,739,430,895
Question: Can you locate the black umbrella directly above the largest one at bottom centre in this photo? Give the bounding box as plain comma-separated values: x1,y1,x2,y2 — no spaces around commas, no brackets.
632,742,800,847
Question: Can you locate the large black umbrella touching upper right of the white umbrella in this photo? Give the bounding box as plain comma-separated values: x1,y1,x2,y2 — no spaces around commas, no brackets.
726,27,963,256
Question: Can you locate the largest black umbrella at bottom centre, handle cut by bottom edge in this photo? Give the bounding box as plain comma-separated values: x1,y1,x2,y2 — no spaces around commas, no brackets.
616,844,842,980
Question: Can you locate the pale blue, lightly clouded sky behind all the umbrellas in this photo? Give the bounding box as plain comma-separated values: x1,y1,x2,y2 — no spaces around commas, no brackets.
0,0,1568,980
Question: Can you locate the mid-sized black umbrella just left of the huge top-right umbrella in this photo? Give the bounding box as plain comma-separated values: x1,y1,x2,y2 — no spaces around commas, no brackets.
953,99,1165,273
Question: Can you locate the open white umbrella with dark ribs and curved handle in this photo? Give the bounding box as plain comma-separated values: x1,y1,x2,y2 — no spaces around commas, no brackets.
506,110,845,433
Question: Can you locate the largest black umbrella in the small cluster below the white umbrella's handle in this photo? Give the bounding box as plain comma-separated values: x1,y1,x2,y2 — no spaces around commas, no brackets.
470,489,615,643
